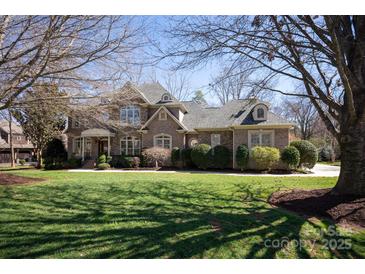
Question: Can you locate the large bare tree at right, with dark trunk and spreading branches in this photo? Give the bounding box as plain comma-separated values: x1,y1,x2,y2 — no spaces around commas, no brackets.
165,16,365,195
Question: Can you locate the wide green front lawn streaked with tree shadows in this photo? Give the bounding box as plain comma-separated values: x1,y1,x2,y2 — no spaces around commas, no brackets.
0,170,365,258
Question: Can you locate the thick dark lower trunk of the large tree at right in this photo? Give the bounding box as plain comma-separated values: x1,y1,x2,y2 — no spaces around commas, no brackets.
333,114,365,196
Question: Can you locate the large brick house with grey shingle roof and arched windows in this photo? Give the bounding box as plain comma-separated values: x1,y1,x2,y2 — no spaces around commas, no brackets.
65,82,293,167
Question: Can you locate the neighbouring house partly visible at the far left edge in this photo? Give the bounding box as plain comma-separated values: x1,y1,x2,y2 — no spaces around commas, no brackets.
0,120,34,163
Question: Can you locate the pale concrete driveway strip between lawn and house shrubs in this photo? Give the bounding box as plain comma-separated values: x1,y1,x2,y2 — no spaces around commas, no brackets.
69,164,340,177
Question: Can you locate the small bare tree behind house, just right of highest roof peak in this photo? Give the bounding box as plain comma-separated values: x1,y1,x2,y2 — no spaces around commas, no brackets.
164,72,192,101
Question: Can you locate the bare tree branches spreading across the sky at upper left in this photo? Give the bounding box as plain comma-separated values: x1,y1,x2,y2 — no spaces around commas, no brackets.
0,16,143,109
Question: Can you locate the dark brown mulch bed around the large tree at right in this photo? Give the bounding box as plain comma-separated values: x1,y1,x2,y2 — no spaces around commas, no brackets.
269,189,365,228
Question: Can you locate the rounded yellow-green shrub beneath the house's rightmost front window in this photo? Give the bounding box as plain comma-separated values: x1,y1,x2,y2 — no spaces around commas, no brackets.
251,146,280,170
